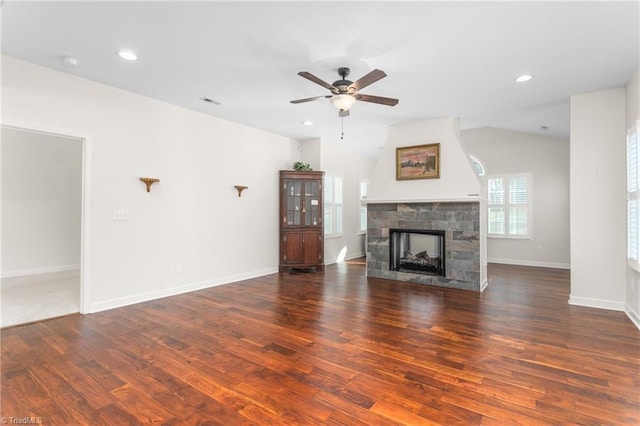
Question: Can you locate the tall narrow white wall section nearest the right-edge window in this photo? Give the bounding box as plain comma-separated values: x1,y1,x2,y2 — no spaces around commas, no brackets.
569,88,626,310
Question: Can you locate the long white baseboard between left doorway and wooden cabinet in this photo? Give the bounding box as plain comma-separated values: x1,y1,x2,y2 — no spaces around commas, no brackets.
86,268,278,313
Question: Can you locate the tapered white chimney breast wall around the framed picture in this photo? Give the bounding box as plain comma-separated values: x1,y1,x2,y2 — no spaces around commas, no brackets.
368,118,480,202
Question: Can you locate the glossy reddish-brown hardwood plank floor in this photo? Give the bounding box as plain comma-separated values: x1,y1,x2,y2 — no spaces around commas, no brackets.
1,262,640,425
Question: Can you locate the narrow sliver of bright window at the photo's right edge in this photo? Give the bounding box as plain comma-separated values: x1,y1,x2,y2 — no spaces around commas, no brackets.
627,121,640,270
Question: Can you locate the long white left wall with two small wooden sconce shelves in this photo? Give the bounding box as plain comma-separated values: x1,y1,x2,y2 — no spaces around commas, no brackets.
2,56,300,312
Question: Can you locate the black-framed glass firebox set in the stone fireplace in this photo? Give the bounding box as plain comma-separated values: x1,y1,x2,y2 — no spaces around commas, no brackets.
389,228,446,277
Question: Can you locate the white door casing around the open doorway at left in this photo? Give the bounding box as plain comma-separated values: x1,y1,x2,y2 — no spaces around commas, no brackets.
0,119,93,314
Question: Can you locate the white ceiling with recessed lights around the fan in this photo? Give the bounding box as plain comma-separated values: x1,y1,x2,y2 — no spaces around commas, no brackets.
1,0,640,155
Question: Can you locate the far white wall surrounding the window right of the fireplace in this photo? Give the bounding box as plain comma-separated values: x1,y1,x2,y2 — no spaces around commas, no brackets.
462,128,568,268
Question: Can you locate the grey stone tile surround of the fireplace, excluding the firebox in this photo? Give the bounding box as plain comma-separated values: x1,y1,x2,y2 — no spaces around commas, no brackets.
367,202,481,291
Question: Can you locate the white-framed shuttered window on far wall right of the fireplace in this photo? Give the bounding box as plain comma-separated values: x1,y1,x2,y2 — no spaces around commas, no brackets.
487,175,531,238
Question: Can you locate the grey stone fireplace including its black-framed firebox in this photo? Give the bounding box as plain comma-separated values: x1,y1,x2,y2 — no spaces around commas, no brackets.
367,201,481,291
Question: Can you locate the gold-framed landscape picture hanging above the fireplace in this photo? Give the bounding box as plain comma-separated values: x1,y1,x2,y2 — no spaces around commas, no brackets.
396,143,440,180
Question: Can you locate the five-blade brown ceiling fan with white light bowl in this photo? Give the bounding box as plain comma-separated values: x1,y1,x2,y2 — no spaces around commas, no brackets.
291,67,398,117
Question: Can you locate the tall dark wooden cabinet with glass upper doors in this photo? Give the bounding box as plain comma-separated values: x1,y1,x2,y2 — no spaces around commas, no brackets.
279,170,324,272
